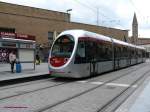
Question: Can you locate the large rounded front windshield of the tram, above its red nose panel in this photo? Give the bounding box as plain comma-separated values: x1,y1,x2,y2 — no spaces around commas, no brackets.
51,35,74,58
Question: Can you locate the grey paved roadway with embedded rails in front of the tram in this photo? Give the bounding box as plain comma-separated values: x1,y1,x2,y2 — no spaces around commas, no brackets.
0,62,150,112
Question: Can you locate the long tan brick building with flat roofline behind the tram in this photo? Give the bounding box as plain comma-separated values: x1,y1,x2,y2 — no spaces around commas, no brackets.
0,2,128,58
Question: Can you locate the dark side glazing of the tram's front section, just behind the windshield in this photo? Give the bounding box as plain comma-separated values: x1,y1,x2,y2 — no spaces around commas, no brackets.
75,41,112,63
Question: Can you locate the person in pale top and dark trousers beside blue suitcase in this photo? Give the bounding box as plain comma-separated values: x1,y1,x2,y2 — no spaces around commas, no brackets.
9,51,16,73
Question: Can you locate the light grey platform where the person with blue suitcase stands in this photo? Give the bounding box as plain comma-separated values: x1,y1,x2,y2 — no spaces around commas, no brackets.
0,63,48,83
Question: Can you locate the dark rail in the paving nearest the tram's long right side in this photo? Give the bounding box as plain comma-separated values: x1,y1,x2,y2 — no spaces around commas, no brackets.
34,63,148,112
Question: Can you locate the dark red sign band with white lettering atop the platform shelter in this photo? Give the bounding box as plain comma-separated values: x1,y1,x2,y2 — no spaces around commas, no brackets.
0,32,35,40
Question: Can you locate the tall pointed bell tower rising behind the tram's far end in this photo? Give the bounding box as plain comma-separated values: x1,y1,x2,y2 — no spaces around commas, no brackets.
131,13,138,45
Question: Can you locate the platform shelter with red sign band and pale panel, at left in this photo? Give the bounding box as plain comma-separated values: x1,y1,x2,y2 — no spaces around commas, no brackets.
0,32,36,69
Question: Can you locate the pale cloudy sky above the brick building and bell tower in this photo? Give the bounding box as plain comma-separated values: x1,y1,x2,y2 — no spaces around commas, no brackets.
0,0,150,38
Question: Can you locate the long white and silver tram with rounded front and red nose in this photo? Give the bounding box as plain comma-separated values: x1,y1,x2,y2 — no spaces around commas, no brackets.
48,30,146,78
